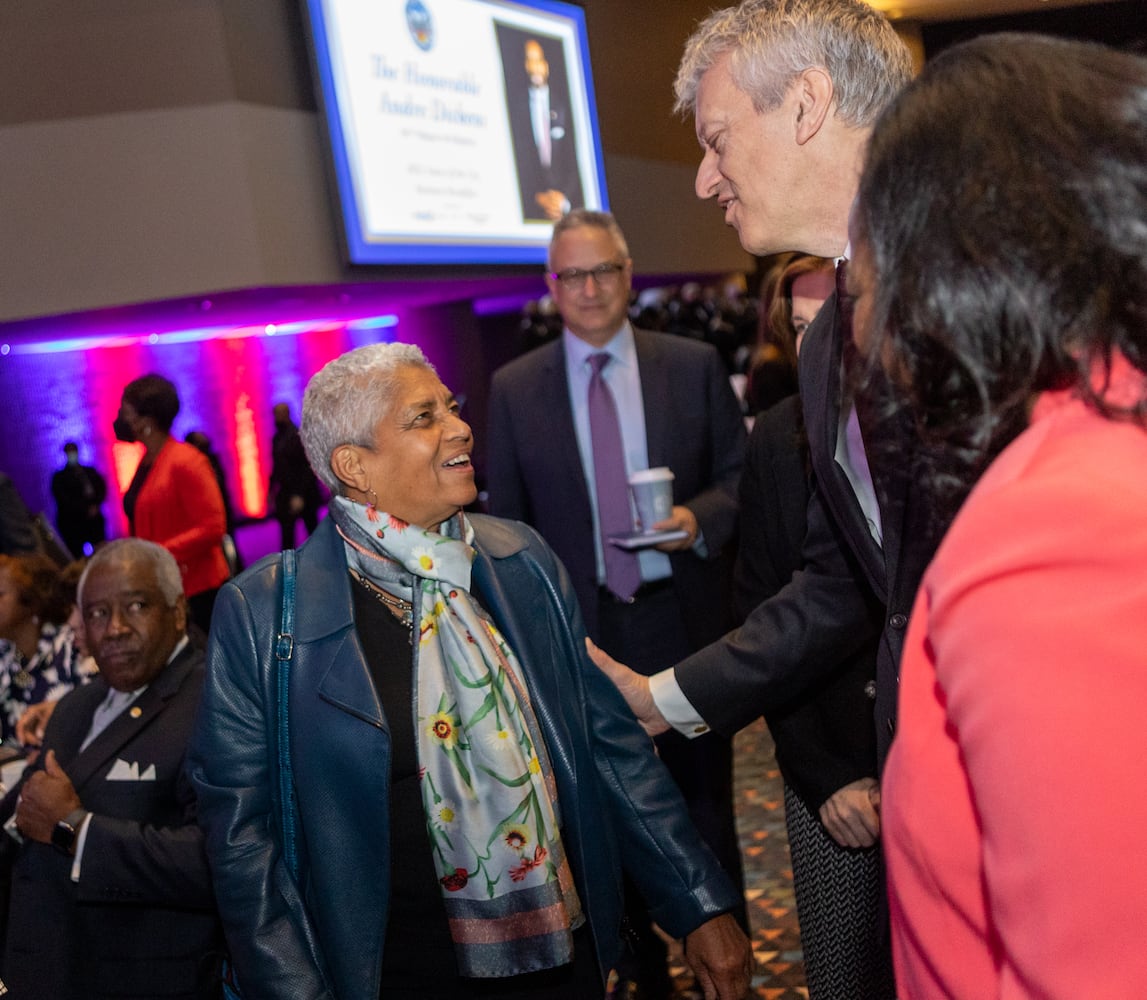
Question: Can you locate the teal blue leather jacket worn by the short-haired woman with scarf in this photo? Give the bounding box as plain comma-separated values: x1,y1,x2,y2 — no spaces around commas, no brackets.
189,515,739,1000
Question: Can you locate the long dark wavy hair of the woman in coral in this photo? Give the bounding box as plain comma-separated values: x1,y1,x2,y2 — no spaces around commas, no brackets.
853,34,1147,516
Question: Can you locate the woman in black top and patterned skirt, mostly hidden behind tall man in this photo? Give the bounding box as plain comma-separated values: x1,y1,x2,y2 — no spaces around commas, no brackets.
733,253,896,1000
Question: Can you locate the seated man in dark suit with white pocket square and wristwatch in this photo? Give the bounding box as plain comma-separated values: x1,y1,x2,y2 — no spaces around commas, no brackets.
0,538,221,1000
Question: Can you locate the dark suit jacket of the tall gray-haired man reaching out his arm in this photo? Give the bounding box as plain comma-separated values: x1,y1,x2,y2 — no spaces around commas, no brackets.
676,296,936,766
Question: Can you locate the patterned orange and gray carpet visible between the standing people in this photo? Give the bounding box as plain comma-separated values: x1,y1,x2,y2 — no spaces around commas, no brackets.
670,720,809,1000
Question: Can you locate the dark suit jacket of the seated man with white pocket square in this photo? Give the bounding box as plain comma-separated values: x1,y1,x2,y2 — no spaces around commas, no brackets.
2,646,223,1000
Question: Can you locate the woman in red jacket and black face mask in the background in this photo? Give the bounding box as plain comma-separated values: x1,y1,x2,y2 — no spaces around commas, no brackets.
115,375,231,632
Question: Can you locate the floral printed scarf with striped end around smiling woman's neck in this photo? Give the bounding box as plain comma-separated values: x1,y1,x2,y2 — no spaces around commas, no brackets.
330,497,584,978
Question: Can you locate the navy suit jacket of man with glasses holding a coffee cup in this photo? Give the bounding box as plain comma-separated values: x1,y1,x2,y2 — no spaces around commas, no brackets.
486,329,746,651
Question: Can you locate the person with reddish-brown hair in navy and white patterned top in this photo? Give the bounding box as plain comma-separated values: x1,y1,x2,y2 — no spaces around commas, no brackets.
0,554,80,742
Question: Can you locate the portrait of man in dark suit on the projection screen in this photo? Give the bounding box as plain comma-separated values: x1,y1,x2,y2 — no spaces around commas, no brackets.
497,24,584,222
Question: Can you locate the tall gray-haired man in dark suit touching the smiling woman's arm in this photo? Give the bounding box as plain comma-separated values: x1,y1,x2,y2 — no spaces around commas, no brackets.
595,0,935,998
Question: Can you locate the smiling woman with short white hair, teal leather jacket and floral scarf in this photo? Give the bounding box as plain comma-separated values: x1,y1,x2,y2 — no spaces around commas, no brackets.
192,344,749,1000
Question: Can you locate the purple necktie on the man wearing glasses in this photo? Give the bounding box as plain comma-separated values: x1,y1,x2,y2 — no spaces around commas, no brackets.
588,352,641,601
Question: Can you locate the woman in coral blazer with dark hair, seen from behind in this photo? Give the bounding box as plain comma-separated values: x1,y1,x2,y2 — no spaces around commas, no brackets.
849,34,1147,1000
